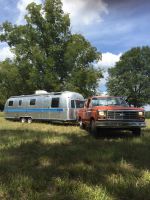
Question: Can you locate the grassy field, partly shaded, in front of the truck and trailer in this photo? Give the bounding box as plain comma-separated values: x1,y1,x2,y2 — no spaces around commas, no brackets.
0,114,150,200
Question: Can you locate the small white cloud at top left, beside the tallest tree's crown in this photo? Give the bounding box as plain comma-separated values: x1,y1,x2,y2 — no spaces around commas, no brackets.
16,0,42,24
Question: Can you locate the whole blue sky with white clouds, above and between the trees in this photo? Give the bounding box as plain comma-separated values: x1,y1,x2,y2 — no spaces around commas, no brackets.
0,0,150,109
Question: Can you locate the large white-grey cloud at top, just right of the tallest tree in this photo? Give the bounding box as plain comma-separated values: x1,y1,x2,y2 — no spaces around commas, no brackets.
62,0,108,29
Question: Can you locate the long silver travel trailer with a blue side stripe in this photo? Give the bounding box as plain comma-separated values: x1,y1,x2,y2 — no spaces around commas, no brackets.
4,91,84,123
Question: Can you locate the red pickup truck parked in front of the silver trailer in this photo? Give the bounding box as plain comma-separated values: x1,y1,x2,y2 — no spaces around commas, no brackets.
77,96,146,136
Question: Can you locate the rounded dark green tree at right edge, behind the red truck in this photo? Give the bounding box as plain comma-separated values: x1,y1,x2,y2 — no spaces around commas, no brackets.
107,47,150,107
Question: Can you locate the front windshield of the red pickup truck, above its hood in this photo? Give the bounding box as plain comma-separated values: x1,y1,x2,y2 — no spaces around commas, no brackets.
92,97,128,107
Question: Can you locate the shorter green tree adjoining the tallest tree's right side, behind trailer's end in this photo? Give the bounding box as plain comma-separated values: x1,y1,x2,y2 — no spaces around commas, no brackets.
65,34,102,97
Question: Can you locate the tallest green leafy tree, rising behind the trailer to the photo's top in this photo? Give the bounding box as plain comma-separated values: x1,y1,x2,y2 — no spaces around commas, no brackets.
0,0,70,93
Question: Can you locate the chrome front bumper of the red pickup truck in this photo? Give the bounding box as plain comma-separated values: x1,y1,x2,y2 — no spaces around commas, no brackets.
96,121,146,129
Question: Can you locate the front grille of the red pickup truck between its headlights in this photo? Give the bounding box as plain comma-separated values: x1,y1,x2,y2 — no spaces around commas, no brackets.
107,111,139,120
